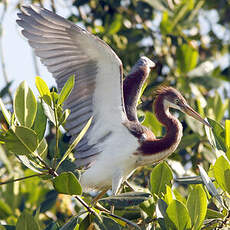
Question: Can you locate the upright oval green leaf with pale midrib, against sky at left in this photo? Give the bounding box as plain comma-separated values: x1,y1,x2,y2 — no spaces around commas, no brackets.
14,81,37,128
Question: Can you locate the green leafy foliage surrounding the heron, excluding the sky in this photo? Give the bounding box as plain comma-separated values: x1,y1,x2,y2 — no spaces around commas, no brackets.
0,0,230,230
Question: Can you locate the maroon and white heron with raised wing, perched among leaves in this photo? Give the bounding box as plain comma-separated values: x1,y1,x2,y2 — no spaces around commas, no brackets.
17,6,209,194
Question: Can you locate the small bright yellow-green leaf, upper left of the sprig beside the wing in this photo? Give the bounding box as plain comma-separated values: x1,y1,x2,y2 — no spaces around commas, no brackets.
35,77,52,106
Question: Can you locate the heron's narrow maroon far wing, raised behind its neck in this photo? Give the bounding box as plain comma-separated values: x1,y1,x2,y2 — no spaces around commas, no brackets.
123,57,155,122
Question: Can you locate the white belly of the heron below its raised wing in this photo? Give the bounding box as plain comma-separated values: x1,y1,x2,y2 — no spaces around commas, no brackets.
80,127,139,192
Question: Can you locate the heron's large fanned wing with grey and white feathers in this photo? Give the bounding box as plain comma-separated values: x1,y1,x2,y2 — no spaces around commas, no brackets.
17,6,126,166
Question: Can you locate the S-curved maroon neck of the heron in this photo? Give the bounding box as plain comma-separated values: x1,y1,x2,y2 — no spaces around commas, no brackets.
140,94,182,157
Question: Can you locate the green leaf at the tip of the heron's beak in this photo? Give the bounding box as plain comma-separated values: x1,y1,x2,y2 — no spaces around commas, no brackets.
205,118,226,152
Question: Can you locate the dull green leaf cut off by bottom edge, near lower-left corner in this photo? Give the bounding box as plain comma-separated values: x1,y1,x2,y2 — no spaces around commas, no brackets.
16,211,40,230
